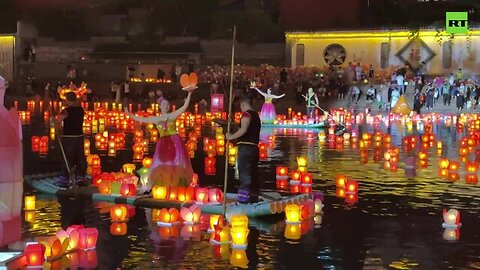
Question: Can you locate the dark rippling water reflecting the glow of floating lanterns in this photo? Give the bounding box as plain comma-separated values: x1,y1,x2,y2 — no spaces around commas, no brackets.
23,106,480,269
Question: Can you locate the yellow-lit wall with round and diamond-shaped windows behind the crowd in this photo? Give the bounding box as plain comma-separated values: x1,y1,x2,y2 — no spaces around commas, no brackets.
286,28,480,75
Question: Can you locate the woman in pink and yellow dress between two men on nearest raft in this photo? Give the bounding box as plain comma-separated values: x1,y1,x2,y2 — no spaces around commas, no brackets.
125,86,197,188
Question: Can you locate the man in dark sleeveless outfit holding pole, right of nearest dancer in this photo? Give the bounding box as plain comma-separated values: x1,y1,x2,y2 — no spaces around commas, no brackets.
225,97,261,203
